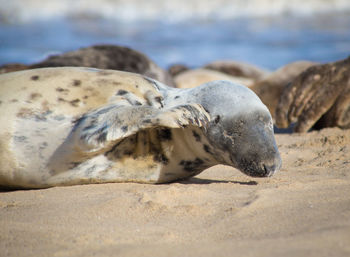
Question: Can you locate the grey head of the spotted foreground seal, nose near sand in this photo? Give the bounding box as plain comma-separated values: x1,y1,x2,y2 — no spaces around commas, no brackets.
193,81,282,177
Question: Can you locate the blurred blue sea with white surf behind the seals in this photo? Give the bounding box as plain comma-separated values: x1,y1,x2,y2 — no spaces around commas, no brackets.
0,0,350,69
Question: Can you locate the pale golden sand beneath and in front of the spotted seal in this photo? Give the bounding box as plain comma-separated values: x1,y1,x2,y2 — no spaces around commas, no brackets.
0,129,350,257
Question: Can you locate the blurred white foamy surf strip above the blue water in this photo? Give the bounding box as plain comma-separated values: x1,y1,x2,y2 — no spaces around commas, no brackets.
0,0,350,24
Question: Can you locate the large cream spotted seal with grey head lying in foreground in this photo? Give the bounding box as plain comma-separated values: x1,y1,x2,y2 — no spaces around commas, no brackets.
0,67,281,188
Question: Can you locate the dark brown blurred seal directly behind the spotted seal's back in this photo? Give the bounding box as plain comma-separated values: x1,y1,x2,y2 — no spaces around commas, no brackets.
0,45,175,86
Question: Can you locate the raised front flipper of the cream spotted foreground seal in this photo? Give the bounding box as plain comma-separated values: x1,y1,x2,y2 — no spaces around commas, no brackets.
48,104,210,174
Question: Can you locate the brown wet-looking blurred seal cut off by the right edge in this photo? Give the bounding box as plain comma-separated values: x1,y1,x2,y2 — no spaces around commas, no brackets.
276,57,350,133
